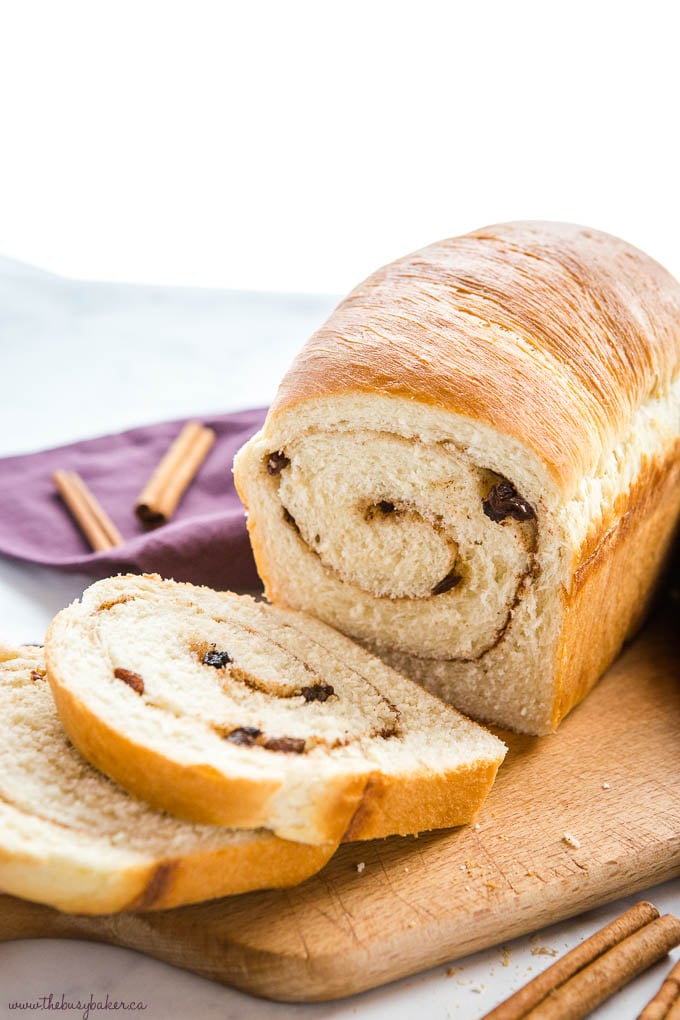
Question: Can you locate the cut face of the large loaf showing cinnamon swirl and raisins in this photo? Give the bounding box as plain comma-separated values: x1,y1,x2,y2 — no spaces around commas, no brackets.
234,395,564,732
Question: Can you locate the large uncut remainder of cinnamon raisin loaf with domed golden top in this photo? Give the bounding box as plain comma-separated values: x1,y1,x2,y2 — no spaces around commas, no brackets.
234,222,680,733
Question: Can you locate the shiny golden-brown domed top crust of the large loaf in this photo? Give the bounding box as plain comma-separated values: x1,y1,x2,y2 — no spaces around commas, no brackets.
271,222,680,494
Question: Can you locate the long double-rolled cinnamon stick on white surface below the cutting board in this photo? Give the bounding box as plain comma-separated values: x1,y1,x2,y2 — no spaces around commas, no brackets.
484,902,680,1020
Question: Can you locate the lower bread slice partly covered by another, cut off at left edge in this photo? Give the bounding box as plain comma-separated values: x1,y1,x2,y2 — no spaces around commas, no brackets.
0,646,333,914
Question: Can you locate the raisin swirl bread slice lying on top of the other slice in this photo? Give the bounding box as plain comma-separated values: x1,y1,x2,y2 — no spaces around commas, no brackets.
46,575,505,844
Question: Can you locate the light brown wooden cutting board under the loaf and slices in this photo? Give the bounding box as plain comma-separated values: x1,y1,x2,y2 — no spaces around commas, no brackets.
0,607,680,1001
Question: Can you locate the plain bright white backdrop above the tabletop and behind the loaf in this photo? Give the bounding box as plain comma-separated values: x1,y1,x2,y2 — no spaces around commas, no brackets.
0,0,680,294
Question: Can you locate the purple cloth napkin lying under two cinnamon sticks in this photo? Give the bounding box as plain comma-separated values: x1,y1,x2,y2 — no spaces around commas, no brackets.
0,408,266,590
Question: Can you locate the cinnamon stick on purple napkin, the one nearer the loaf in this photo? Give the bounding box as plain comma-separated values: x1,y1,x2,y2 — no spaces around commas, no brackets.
135,421,215,524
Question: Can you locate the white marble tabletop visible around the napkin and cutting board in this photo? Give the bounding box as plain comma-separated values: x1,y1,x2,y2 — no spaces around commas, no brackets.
0,260,680,1020
